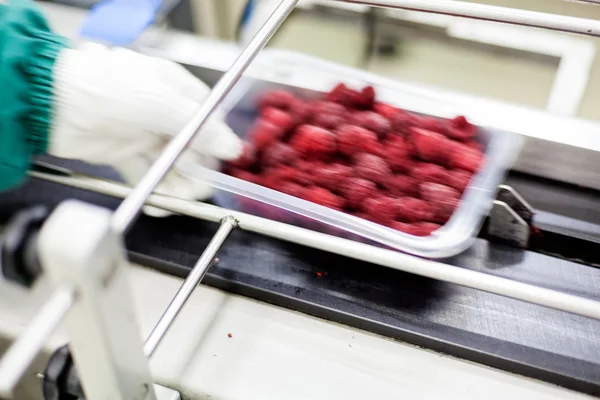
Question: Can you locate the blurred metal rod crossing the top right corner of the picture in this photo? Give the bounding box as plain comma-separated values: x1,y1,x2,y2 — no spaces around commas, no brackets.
335,0,600,37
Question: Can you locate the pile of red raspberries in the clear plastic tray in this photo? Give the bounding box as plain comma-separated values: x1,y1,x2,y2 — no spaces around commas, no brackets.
225,83,483,236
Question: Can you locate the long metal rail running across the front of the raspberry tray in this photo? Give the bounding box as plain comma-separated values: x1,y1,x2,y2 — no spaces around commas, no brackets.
32,173,600,320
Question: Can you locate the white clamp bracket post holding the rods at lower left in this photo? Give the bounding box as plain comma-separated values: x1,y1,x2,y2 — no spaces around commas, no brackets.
38,200,156,400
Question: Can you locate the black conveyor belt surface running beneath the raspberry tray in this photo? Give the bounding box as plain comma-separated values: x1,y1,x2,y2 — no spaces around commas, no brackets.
0,172,600,395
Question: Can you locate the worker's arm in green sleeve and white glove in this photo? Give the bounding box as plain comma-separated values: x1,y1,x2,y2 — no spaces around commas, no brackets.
0,0,242,216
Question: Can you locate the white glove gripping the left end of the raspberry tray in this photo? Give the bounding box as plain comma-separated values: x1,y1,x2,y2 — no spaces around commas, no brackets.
49,43,242,216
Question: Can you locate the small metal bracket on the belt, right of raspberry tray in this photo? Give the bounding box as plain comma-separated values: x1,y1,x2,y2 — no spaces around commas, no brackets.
487,185,534,248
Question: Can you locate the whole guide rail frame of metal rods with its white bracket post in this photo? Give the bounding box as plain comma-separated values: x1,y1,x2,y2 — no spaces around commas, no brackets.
0,0,600,400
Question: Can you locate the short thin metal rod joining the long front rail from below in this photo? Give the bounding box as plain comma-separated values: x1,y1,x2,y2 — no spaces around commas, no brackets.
144,216,237,357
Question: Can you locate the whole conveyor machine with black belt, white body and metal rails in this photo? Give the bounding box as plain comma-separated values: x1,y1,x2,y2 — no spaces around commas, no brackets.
0,0,600,400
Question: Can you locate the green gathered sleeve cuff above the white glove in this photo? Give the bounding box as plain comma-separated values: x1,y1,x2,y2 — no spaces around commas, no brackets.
0,0,66,191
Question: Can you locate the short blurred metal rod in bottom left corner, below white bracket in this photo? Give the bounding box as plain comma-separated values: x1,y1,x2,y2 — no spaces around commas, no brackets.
0,289,75,399
